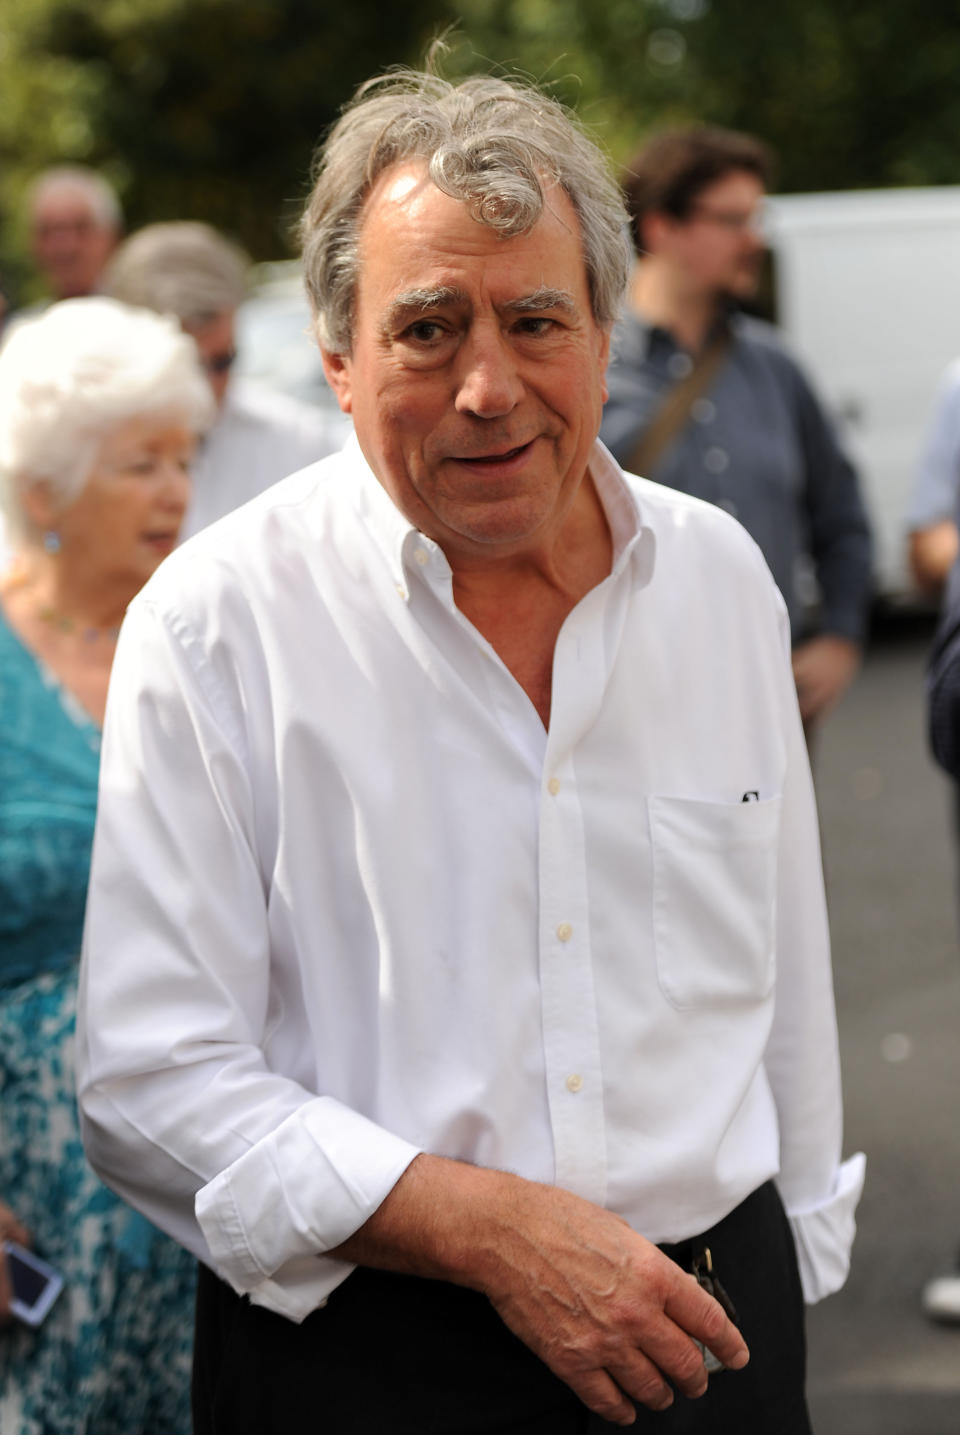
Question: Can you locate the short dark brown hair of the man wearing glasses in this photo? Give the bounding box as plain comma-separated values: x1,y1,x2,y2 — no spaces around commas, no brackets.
623,125,773,254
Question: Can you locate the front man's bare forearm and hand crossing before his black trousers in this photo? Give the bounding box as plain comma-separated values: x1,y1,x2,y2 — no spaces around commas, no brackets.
333,1155,749,1425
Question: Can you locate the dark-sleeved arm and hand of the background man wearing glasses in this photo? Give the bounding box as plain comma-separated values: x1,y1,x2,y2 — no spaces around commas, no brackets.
788,360,872,722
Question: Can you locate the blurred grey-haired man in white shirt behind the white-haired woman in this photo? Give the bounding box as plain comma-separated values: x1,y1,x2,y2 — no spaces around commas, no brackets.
103,220,350,537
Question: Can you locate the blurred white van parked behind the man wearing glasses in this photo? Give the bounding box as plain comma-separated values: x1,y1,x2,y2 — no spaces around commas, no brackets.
768,185,960,601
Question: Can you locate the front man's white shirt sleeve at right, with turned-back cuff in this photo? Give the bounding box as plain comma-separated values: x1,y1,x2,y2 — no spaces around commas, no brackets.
765,594,865,1304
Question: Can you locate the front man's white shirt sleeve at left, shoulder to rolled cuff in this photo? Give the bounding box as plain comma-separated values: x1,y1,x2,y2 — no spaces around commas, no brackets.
77,600,418,1319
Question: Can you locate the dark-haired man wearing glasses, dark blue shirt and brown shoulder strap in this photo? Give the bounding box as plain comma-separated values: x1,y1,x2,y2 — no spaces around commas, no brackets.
600,126,871,735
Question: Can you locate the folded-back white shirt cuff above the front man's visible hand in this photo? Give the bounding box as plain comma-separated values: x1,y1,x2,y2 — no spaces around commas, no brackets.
195,1096,419,1320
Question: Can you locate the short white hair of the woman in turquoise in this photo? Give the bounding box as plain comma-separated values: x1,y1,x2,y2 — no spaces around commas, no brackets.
0,297,215,538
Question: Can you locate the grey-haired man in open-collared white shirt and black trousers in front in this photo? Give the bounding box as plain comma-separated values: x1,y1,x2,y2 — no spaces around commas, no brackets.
80,61,862,1435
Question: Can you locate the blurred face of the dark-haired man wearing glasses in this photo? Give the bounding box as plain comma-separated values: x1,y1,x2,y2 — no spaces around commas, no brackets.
663,169,766,298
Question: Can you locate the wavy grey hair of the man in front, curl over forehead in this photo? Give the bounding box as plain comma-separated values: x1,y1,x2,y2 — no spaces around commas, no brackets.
300,70,631,353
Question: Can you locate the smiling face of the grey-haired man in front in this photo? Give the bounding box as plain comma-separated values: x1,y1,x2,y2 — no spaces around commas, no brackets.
324,162,608,560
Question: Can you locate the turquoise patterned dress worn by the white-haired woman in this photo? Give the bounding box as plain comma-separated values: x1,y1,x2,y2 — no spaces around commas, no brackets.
0,616,195,1435
